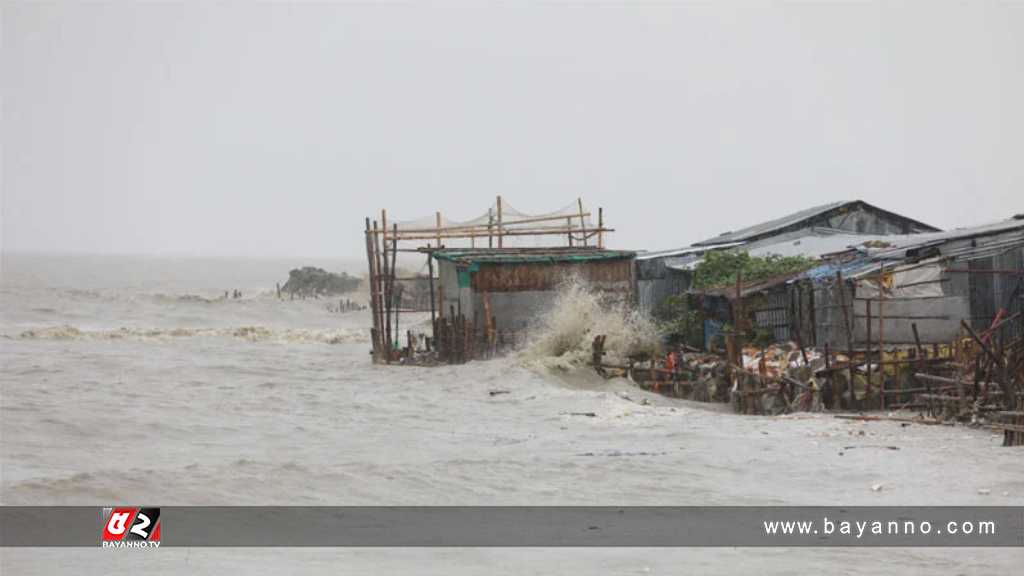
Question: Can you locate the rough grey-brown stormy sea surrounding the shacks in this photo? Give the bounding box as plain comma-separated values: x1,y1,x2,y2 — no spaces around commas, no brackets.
0,254,1024,575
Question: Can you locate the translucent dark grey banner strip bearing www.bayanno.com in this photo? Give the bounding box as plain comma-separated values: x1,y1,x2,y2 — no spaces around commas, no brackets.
0,506,1024,546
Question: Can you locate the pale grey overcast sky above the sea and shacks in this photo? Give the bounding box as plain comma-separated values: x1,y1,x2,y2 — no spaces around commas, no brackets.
0,1,1024,257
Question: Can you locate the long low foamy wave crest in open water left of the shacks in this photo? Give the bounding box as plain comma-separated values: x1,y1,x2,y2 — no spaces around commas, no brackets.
8,325,370,344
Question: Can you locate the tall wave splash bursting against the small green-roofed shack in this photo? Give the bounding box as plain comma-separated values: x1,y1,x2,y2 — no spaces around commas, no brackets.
521,279,660,370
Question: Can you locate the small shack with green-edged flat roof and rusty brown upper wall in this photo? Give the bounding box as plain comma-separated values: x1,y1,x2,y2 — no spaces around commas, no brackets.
433,247,635,347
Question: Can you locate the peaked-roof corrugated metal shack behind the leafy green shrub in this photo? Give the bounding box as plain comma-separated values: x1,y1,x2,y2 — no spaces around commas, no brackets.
637,200,939,317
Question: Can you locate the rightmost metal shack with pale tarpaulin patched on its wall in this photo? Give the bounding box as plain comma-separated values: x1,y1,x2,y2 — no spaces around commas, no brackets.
787,216,1024,349
